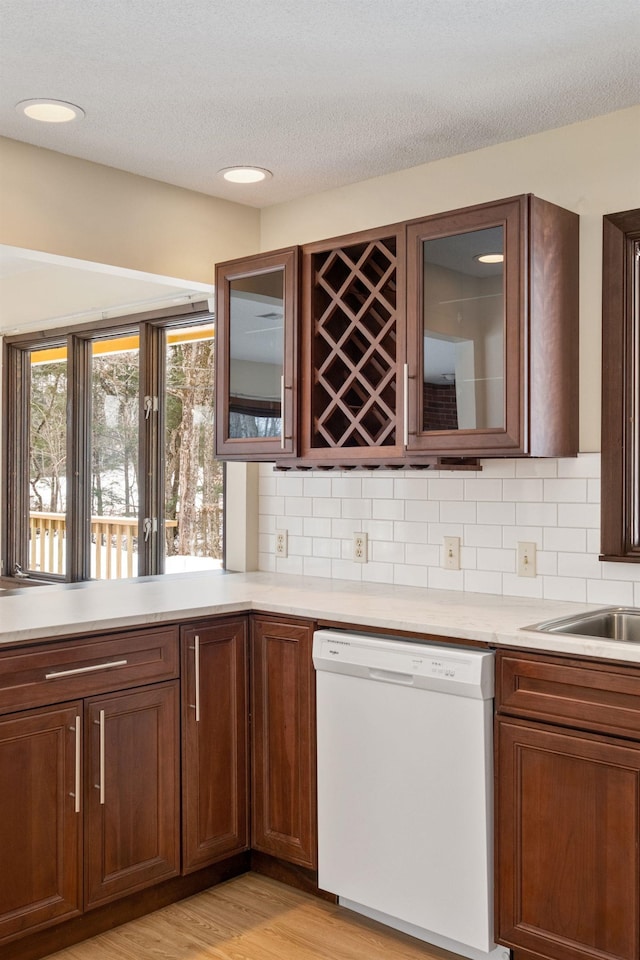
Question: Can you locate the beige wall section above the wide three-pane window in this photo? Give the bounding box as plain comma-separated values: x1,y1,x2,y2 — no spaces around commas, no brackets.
0,138,260,283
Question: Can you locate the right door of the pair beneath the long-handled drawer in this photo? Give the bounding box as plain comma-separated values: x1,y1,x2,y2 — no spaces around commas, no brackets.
85,681,180,908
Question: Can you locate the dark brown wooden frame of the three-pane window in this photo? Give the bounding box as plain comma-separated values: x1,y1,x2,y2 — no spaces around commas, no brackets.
2,301,218,583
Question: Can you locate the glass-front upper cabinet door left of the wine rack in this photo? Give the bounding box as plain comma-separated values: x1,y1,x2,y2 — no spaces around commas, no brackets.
216,247,299,460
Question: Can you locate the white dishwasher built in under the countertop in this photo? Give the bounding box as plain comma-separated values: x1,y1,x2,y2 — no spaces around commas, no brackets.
313,630,509,960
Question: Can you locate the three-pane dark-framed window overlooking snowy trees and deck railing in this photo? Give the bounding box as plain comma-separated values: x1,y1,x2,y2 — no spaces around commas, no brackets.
3,306,224,581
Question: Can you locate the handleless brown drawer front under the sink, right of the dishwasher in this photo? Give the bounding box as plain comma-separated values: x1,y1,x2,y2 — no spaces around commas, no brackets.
496,651,640,739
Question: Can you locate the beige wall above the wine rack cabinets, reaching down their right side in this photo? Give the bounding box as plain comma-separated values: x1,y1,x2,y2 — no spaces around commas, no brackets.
261,107,640,451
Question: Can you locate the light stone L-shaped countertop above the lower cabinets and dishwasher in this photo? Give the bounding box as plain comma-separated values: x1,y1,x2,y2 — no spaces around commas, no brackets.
0,571,640,663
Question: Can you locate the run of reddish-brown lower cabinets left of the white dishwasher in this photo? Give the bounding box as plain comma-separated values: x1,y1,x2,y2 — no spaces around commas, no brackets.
0,615,316,956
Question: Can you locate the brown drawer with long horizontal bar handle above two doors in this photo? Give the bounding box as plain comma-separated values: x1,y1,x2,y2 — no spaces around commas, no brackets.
0,626,179,713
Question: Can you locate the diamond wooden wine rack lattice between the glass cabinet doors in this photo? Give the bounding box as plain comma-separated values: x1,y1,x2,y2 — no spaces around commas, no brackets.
312,237,397,448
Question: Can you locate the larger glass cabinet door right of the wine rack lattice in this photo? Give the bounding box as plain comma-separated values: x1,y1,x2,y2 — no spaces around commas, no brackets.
405,201,521,455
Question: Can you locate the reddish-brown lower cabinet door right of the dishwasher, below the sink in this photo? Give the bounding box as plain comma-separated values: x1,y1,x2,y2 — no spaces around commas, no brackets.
497,720,640,960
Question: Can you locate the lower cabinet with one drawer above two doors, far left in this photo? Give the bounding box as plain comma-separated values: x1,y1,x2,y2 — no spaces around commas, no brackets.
0,625,180,952
